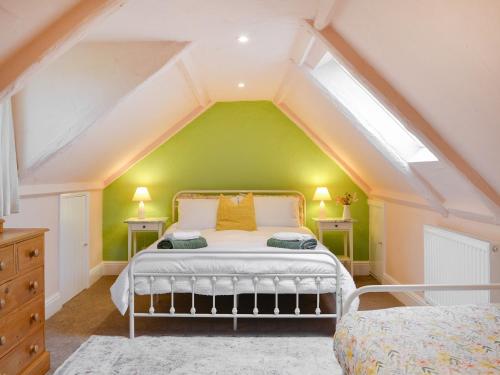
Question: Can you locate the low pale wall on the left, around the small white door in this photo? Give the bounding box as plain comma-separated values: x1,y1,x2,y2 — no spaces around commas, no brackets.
5,190,102,317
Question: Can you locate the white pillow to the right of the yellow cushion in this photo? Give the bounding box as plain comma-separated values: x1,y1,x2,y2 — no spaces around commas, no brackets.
253,196,300,227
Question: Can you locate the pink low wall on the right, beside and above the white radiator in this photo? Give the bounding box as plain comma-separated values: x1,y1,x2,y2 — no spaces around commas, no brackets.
385,202,500,284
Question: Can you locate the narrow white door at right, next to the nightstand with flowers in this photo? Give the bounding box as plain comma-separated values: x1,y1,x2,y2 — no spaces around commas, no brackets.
369,202,385,282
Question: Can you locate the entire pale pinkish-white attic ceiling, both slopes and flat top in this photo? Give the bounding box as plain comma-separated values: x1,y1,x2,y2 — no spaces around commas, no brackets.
0,0,500,222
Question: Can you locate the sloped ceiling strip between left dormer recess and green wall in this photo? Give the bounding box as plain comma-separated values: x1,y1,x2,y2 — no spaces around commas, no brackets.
23,67,198,184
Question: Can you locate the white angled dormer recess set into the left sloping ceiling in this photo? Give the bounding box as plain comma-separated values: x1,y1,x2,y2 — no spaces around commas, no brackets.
14,42,189,178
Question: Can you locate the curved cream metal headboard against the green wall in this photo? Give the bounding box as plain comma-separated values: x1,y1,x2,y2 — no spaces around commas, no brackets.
172,190,306,225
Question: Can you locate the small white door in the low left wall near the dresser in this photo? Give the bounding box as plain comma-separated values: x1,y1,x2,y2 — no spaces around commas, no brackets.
59,193,89,303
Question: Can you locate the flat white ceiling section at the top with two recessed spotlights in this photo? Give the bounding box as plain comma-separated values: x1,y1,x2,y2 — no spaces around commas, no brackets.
87,0,317,101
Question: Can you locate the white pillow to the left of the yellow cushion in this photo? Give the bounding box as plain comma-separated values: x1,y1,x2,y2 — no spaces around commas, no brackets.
177,198,219,229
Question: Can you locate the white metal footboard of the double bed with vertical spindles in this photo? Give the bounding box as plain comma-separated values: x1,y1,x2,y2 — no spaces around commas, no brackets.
128,249,343,338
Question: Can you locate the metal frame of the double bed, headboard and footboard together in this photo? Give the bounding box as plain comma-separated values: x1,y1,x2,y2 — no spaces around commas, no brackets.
128,190,343,338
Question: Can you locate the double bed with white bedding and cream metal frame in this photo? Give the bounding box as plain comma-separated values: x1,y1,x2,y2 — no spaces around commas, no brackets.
111,191,357,338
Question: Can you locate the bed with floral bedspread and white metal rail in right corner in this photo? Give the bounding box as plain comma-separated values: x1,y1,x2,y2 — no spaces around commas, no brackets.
334,284,500,374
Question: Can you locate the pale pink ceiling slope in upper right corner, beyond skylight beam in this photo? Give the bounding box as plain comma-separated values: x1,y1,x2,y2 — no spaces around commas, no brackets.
332,0,500,192
